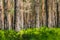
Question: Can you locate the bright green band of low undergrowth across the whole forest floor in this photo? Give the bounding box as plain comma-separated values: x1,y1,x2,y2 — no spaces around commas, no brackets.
0,27,60,40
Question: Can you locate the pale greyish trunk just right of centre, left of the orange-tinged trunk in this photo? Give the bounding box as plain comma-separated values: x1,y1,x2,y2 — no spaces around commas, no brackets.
35,0,40,27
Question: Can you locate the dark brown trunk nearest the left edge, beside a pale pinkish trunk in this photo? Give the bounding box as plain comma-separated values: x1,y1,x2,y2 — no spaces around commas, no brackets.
4,0,8,29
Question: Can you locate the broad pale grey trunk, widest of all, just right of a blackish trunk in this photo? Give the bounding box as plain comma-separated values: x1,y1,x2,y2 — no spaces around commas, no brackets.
15,0,23,31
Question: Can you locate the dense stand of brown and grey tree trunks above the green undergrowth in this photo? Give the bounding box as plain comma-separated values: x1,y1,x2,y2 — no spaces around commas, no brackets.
0,0,60,31
